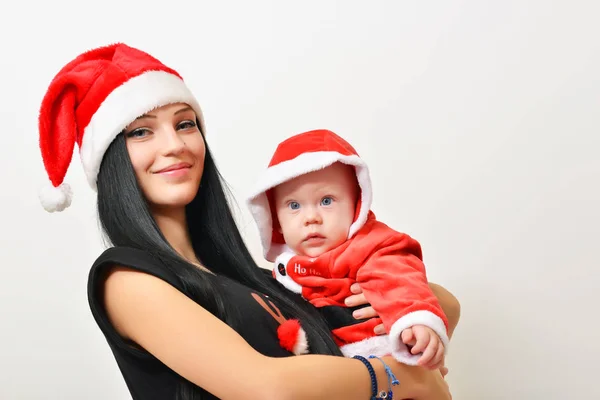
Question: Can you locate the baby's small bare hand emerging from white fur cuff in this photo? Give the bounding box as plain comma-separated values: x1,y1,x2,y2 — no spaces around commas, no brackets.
401,325,444,369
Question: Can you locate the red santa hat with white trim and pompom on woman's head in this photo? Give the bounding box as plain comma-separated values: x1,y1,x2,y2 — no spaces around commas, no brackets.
39,43,205,212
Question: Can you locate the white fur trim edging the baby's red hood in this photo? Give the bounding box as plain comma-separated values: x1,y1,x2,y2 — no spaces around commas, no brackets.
247,151,373,262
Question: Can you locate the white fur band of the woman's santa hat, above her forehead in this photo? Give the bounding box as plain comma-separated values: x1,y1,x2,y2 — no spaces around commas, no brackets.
80,71,205,190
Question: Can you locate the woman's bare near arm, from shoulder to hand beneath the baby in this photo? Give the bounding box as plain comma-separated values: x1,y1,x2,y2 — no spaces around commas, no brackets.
104,268,450,400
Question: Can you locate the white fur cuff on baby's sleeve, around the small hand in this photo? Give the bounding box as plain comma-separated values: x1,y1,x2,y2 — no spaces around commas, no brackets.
390,311,450,365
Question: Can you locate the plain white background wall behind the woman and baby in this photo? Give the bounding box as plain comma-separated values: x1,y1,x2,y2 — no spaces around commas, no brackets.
0,0,600,400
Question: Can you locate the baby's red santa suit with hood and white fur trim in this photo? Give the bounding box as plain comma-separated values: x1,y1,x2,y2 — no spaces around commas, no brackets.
248,130,448,365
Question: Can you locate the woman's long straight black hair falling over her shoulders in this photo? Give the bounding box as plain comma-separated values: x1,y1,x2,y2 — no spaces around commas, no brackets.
98,130,342,400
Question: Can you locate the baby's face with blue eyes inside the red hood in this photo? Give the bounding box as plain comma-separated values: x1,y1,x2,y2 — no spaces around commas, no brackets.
274,163,359,257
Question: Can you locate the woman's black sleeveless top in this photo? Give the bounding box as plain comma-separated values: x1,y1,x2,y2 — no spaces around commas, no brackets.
88,247,292,400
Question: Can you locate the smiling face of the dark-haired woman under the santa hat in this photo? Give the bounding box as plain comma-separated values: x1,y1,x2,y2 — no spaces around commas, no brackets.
124,103,206,209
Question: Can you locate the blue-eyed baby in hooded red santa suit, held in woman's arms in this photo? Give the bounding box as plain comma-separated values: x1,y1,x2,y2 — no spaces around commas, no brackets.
248,130,449,369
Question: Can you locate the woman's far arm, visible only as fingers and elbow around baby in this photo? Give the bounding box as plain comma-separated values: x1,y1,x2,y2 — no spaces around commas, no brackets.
346,282,460,337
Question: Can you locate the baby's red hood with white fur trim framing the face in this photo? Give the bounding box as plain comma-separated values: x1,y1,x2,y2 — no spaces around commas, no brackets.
247,129,373,262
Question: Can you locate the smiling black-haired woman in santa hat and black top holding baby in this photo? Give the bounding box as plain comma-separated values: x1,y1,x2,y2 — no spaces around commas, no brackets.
39,44,457,400
